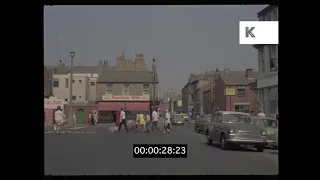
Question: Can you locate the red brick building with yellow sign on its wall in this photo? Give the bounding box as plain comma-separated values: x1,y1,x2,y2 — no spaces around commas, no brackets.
215,69,259,112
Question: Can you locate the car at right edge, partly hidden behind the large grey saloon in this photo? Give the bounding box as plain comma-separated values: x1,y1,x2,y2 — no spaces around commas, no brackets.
252,116,278,147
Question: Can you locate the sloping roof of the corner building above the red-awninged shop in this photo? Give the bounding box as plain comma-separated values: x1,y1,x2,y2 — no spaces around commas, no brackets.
97,71,159,83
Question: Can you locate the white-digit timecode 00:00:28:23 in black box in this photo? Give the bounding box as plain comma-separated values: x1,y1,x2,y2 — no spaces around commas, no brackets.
133,144,188,158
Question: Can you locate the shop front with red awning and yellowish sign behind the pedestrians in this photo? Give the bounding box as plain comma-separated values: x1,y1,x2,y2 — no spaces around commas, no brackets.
96,95,150,123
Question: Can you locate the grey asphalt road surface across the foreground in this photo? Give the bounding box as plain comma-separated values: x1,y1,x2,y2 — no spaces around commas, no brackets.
45,124,278,175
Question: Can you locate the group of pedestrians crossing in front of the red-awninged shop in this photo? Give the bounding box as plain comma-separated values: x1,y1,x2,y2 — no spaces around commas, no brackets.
118,108,171,133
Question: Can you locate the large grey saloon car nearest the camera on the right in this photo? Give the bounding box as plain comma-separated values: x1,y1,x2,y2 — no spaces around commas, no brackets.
205,111,268,152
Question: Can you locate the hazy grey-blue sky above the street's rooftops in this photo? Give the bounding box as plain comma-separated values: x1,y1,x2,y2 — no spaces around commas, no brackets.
44,5,266,96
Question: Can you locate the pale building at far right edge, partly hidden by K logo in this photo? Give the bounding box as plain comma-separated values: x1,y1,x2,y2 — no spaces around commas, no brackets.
253,6,278,115
